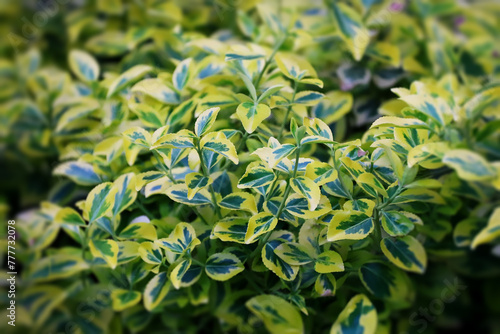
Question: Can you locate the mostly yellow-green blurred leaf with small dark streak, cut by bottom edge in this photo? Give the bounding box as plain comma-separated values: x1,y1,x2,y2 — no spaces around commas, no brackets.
245,295,304,334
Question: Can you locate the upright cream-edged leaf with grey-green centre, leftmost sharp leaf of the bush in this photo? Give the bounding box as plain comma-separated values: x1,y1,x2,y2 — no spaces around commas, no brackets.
84,182,117,223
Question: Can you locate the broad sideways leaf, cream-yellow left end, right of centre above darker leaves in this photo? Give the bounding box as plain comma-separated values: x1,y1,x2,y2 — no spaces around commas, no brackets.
328,211,374,241
